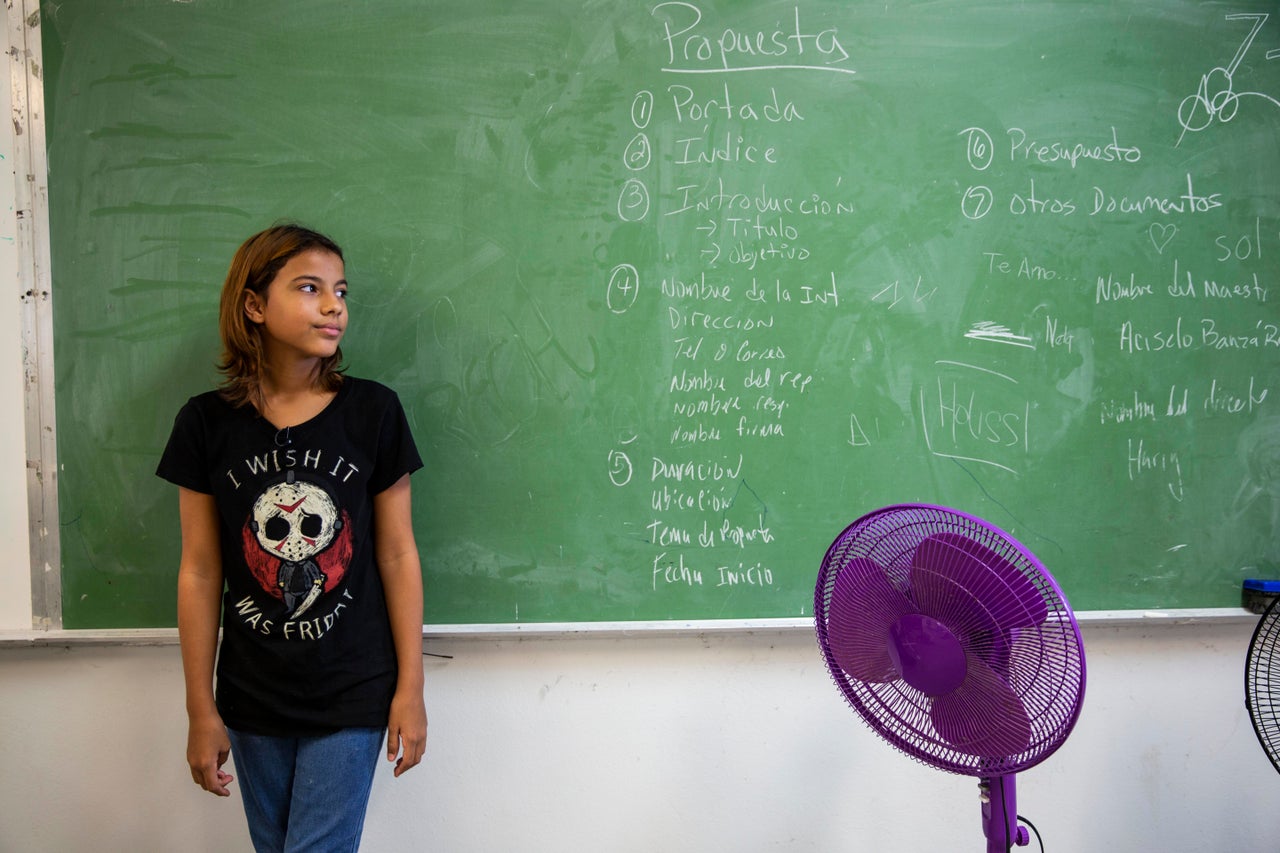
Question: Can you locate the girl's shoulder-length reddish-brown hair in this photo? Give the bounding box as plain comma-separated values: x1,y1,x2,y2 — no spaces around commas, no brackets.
218,223,342,409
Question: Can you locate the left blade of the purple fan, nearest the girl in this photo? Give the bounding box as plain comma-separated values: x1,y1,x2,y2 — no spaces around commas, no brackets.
827,557,915,684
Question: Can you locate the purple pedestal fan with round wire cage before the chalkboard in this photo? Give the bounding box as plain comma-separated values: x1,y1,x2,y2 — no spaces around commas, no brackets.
814,503,1084,853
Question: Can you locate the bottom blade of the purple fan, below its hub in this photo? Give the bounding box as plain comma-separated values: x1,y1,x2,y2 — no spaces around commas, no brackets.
929,654,1032,760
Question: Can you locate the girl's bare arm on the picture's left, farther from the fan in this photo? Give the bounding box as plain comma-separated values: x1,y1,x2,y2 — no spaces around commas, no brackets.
178,488,232,797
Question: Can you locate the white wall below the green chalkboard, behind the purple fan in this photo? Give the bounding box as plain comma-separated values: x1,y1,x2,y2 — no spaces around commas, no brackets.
0,622,1280,853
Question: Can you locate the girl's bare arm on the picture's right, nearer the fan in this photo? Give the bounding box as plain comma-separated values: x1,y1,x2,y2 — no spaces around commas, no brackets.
374,474,426,776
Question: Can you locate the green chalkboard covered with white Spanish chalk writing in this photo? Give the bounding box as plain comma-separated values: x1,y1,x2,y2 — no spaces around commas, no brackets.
41,0,1280,628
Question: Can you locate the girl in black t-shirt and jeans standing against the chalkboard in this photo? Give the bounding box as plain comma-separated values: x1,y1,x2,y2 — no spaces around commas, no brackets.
157,225,426,850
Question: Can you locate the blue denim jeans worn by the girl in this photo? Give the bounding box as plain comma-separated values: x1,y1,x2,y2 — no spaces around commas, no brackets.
227,729,383,853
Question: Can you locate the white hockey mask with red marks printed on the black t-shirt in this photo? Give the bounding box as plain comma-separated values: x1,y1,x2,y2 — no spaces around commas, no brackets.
253,482,342,562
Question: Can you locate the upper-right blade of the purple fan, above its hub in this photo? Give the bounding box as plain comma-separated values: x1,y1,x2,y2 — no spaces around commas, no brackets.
911,533,1048,633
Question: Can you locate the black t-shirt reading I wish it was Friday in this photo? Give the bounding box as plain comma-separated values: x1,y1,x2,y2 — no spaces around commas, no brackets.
156,377,422,735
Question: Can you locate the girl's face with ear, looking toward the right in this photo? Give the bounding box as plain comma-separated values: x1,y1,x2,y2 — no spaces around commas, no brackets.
244,248,347,361
